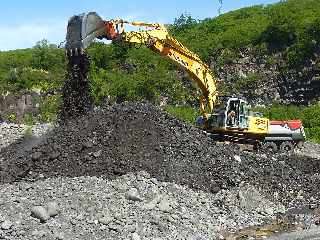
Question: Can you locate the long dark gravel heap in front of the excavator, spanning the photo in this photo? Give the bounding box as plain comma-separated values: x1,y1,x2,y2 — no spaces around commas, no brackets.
0,103,320,205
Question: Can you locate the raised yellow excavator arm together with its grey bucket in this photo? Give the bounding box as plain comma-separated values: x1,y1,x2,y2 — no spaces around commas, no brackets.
66,12,218,118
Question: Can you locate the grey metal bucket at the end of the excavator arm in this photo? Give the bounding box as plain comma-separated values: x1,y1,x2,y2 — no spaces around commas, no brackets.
65,12,106,55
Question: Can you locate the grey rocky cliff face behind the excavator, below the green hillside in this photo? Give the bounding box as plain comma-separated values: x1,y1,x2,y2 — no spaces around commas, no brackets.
211,49,320,105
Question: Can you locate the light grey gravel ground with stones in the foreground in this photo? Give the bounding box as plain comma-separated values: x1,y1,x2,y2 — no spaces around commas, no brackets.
0,172,284,240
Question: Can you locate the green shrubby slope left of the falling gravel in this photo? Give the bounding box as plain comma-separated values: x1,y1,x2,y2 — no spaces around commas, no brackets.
0,40,66,93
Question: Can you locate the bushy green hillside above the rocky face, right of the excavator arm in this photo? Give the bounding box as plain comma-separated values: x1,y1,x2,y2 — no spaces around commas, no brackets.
174,0,320,60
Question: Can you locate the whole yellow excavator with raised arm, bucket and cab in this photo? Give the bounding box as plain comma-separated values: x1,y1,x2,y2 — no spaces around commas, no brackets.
66,12,305,151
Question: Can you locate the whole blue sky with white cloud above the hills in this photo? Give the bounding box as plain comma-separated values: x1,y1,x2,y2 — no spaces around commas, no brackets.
0,0,278,50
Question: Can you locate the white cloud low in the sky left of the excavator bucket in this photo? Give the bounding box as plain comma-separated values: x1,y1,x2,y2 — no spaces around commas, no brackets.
0,20,68,51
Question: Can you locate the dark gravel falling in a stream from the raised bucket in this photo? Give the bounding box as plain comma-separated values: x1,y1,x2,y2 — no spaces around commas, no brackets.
59,54,92,122
